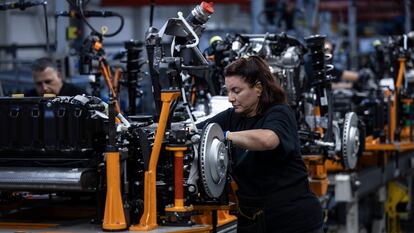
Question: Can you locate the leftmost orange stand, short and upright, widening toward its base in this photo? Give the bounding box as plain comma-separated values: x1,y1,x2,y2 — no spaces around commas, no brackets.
102,151,127,230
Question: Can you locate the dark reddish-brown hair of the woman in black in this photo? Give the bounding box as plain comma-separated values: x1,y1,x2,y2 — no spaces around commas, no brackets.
224,56,286,114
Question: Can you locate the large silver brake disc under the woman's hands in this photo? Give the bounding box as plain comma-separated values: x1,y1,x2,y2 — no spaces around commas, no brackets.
199,123,229,198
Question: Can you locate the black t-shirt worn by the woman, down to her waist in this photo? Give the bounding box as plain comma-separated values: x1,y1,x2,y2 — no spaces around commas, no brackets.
199,104,307,196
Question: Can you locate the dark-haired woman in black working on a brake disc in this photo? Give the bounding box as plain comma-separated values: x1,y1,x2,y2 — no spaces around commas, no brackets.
198,56,323,233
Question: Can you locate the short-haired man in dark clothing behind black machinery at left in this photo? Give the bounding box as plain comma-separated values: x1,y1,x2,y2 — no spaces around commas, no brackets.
25,57,87,96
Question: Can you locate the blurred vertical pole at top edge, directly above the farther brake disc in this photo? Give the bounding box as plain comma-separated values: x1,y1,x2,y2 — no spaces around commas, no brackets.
348,0,358,70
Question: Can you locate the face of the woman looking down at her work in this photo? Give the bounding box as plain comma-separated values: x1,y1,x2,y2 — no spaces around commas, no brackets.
225,75,262,117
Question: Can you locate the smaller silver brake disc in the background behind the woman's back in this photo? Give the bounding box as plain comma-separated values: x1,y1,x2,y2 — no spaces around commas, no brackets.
342,112,360,169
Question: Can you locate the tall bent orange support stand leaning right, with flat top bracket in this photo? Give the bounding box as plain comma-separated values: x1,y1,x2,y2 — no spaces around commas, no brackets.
129,90,181,231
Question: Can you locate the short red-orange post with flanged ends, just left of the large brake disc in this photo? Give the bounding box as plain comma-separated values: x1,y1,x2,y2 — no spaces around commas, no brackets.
165,146,193,212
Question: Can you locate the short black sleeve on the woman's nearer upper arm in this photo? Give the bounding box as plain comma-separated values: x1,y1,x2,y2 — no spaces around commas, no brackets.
262,105,300,156
